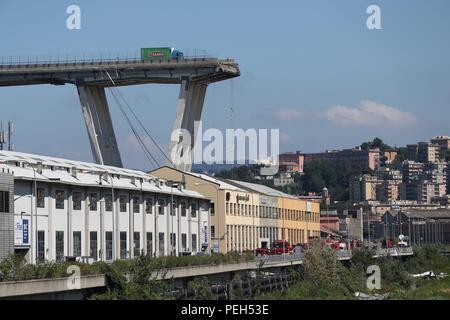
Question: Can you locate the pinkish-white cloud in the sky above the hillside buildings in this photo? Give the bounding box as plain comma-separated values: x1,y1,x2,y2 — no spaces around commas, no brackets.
322,101,417,127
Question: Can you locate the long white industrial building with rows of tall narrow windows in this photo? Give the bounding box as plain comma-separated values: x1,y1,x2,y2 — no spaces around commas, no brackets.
0,151,210,263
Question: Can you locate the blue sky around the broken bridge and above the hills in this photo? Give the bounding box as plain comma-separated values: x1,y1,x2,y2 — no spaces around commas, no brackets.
0,0,450,169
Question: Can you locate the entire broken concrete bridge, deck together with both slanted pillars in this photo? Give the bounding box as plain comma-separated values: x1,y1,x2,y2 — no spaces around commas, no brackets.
0,56,240,171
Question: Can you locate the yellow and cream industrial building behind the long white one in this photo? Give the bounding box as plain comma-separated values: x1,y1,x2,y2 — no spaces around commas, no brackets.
151,167,320,253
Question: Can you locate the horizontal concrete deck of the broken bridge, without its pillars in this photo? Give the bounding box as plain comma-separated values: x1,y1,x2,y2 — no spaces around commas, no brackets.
0,58,240,87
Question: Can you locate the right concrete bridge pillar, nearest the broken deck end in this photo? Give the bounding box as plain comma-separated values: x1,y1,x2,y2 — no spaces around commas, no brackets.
169,79,208,172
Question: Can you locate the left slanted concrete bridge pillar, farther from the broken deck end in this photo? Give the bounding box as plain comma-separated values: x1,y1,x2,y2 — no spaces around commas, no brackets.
77,85,122,167
